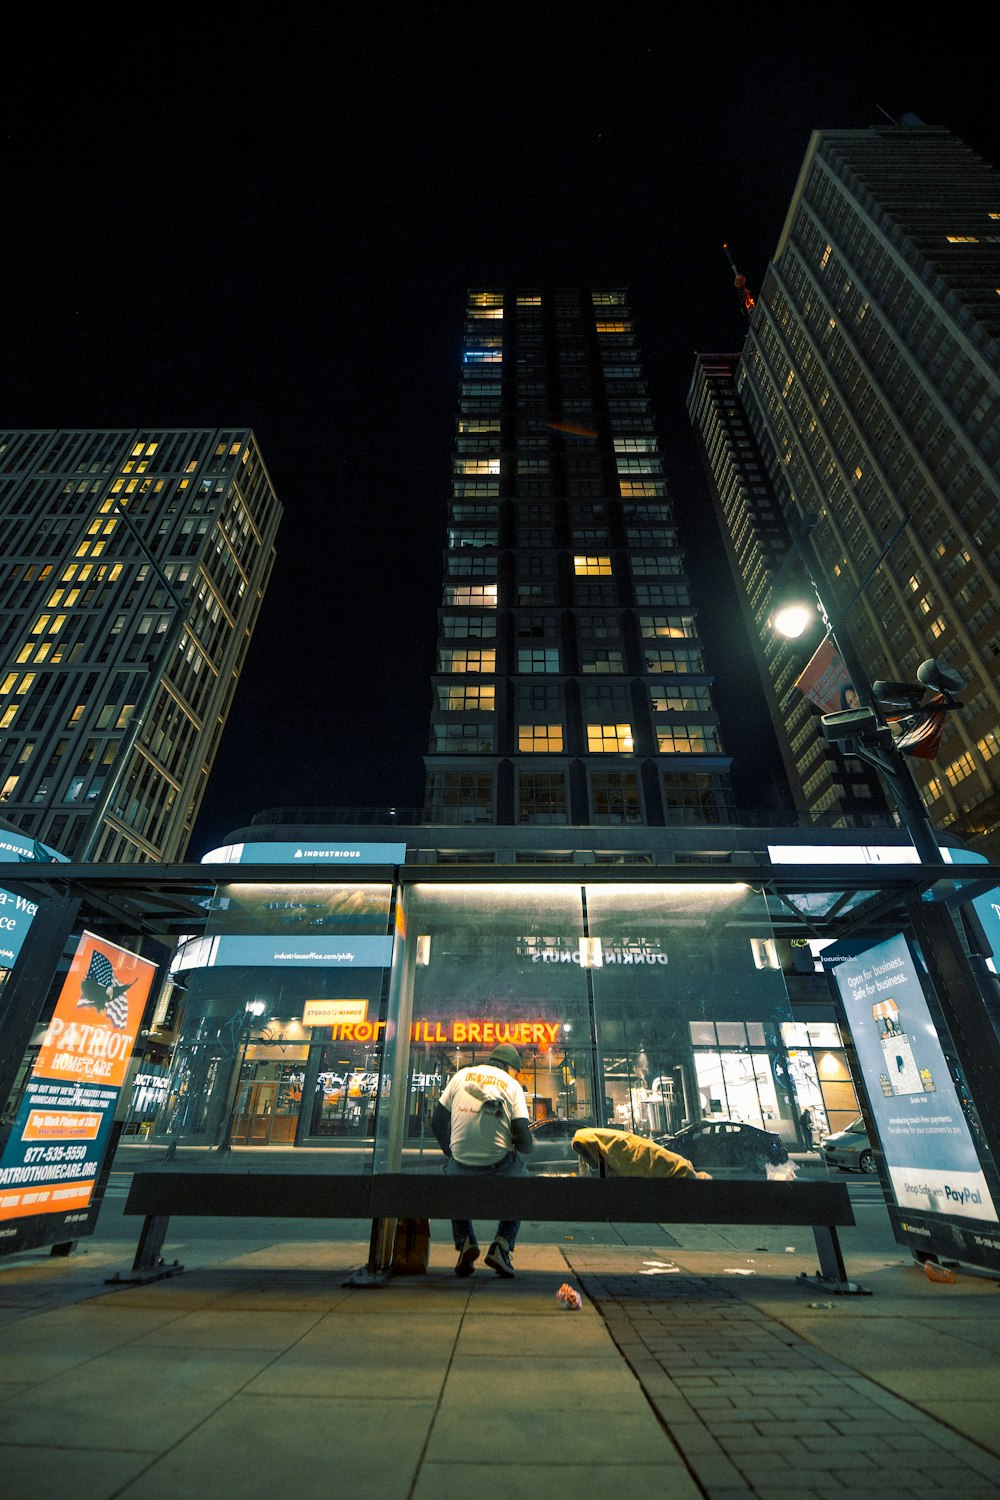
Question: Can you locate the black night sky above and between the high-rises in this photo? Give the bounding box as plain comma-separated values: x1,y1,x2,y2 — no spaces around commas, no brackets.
0,5,1000,858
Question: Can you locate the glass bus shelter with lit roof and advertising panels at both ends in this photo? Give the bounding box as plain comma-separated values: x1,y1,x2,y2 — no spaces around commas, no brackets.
0,848,1000,1269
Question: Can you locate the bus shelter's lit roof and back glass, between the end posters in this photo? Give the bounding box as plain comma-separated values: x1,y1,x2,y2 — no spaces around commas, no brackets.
9,830,1000,1172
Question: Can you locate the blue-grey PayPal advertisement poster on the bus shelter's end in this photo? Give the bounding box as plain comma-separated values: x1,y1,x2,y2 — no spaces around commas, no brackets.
834,936,997,1223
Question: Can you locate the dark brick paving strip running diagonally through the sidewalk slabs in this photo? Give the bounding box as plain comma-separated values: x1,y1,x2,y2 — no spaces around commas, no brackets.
570,1253,1000,1500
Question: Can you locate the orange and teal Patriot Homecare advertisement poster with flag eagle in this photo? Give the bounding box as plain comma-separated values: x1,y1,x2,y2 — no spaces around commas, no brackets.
0,933,156,1253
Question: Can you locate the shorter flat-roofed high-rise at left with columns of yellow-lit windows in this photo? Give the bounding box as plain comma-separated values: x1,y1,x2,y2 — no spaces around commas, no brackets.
0,428,280,863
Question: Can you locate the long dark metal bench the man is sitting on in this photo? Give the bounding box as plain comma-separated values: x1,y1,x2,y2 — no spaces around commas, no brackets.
111,1169,864,1293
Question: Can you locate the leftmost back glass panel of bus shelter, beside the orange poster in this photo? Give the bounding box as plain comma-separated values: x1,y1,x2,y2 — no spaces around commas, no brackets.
154,882,391,1172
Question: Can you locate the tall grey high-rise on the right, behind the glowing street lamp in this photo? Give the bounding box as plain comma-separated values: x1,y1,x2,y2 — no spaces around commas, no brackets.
688,122,1000,855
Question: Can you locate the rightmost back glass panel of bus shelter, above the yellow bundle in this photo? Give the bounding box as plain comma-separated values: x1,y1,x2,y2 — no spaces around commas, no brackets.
586,882,799,1176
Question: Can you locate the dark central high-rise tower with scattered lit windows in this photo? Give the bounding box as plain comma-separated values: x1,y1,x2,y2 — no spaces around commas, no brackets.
424,288,733,825
